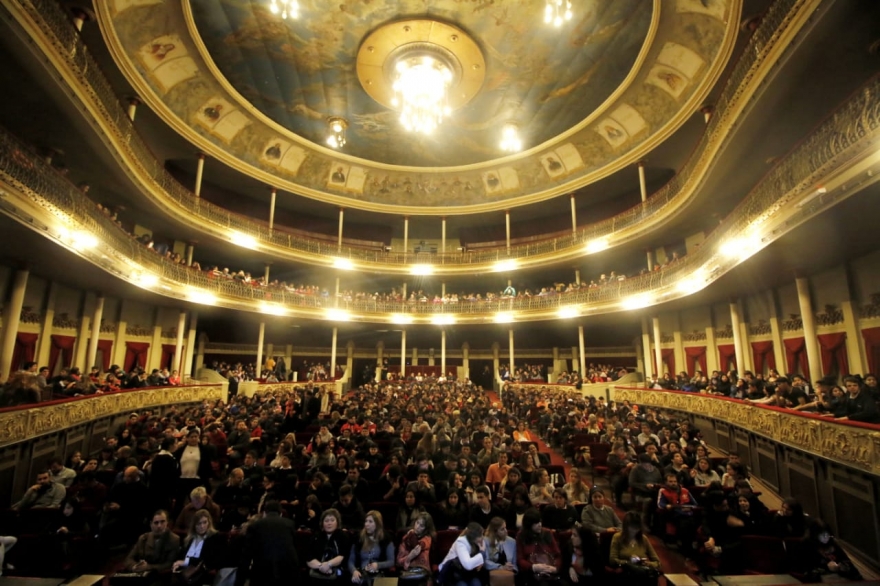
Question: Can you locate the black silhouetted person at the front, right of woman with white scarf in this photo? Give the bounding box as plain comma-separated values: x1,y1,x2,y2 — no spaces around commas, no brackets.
235,501,300,586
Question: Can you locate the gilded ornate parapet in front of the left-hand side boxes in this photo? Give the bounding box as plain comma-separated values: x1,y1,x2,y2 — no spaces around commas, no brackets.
0,384,227,447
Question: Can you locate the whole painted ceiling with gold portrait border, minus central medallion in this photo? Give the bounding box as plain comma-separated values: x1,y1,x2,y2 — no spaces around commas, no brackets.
95,0,742,210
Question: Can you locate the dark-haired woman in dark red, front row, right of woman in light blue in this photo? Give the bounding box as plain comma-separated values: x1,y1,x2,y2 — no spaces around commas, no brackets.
516,509,562,586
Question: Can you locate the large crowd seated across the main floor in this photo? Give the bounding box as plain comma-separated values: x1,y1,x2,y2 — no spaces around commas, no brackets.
0,377,858,586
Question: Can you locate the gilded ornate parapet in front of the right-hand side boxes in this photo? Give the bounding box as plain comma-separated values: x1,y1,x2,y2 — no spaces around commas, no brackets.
612,387,880,474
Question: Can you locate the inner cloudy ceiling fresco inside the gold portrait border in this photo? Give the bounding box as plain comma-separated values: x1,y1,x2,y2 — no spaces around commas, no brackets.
191,0,653,167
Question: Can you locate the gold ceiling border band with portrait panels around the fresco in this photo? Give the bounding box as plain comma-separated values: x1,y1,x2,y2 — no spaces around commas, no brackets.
96,0,741,215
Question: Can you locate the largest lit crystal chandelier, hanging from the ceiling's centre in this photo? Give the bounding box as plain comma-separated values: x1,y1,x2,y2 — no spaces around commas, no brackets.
391,55,453,134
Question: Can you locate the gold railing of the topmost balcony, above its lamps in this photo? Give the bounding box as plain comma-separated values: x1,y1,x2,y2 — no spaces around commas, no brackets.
10,0,813,270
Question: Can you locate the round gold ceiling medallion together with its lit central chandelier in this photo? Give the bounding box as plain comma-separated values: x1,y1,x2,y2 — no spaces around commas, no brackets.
357,18,486,134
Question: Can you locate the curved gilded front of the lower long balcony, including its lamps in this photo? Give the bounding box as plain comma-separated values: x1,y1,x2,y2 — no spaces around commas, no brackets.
0,67,880,325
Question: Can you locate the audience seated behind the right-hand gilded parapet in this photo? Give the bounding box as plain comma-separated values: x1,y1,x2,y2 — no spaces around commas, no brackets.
648,369,880,423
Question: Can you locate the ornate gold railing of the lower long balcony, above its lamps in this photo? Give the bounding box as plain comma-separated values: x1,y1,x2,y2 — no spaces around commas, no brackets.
0,76,880,322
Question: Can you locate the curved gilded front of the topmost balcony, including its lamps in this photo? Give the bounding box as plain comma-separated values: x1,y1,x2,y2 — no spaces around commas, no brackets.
0,0,836,274
